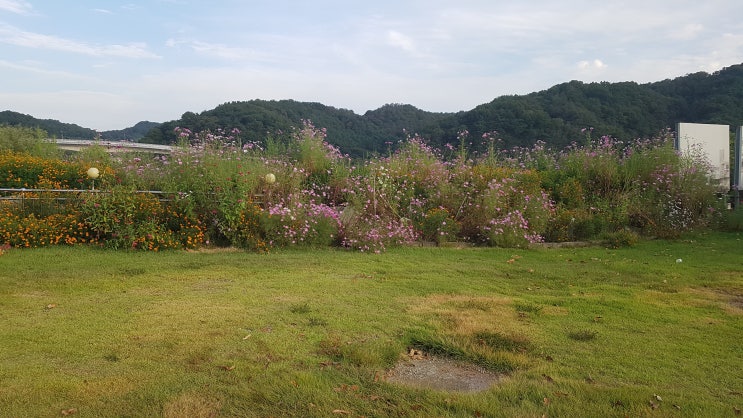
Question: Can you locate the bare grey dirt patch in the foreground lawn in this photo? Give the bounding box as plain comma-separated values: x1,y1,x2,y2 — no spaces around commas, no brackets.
386,352,503,392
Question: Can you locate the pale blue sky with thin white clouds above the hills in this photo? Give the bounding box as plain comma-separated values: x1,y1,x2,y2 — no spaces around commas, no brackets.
0,0,743,131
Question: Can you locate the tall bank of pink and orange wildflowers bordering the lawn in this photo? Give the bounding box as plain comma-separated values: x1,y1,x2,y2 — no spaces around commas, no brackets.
0,121,729,252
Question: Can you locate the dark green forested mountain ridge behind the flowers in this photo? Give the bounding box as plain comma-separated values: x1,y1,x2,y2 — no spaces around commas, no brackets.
0,64,743,156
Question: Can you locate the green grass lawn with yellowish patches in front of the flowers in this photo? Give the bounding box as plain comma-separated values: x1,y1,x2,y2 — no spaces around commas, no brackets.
0,233,743,417
